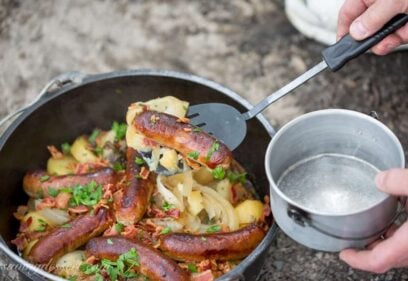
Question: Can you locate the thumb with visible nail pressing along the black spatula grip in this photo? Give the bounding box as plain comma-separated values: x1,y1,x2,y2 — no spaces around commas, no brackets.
350,0,408,40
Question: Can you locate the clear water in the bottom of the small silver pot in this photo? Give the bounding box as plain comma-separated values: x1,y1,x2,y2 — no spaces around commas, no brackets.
277,154,387,215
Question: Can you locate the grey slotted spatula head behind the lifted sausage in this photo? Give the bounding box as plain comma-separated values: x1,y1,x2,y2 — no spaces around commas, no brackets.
187,103,247,150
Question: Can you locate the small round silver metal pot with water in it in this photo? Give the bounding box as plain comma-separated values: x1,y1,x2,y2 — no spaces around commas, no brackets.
265,109,405,251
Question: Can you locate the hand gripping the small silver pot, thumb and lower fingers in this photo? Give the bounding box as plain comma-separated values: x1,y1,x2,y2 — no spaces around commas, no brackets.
340,169,408,273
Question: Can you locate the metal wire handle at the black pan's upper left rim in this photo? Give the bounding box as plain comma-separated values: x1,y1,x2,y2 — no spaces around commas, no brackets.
0,71,86,131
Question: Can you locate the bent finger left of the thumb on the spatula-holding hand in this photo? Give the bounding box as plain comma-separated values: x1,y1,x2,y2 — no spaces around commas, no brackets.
337,0,367,40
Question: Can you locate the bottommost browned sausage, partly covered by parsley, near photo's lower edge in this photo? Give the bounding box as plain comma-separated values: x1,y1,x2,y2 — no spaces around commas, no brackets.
86,236,190,281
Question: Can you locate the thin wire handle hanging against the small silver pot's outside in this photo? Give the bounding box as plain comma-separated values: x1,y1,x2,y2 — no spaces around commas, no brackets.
287,201,406,240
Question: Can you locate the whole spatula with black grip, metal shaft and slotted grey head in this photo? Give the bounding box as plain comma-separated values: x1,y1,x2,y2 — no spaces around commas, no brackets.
188,14,408,150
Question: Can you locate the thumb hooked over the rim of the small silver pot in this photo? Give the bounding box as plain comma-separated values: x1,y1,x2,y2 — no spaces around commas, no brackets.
375,169,408,195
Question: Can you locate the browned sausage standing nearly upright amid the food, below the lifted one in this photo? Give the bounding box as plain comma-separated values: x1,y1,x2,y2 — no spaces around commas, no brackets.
115,147,155,225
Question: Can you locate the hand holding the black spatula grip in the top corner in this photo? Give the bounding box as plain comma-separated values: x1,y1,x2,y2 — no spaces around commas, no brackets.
337,0,408,55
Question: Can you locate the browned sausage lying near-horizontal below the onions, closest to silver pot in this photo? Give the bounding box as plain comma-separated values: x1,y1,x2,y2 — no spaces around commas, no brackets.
160,224,265,261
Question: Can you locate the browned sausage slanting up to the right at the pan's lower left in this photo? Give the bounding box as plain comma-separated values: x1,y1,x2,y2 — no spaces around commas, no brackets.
28,208,112,264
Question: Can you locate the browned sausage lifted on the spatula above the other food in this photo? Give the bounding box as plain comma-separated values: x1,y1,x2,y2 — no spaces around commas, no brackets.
133,111,232,168
